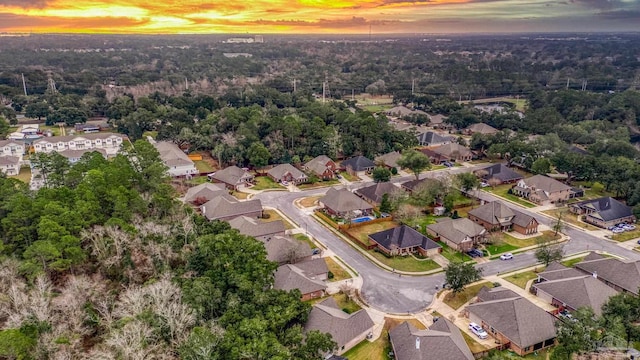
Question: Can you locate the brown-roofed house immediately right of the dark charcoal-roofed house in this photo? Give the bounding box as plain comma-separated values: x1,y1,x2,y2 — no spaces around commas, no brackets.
427,218,487,251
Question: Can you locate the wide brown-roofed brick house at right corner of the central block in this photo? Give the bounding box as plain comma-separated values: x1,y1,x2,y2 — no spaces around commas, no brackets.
467,201,539,235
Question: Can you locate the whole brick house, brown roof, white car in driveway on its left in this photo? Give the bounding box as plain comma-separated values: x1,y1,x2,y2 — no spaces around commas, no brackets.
465,288,556,356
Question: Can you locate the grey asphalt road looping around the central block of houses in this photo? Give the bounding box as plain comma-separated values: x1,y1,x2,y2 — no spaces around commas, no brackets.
254,167,640,314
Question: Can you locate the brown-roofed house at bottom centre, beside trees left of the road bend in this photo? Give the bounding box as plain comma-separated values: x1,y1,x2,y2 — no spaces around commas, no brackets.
304,297,375,355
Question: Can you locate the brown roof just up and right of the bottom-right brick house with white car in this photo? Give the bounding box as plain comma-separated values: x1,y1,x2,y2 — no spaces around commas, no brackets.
534,276,618,315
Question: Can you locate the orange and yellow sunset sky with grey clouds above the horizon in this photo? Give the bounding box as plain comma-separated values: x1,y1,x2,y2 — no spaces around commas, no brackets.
0,0,640,34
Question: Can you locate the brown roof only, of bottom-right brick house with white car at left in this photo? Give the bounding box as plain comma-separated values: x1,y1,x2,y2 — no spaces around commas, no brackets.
467,297,556,348
